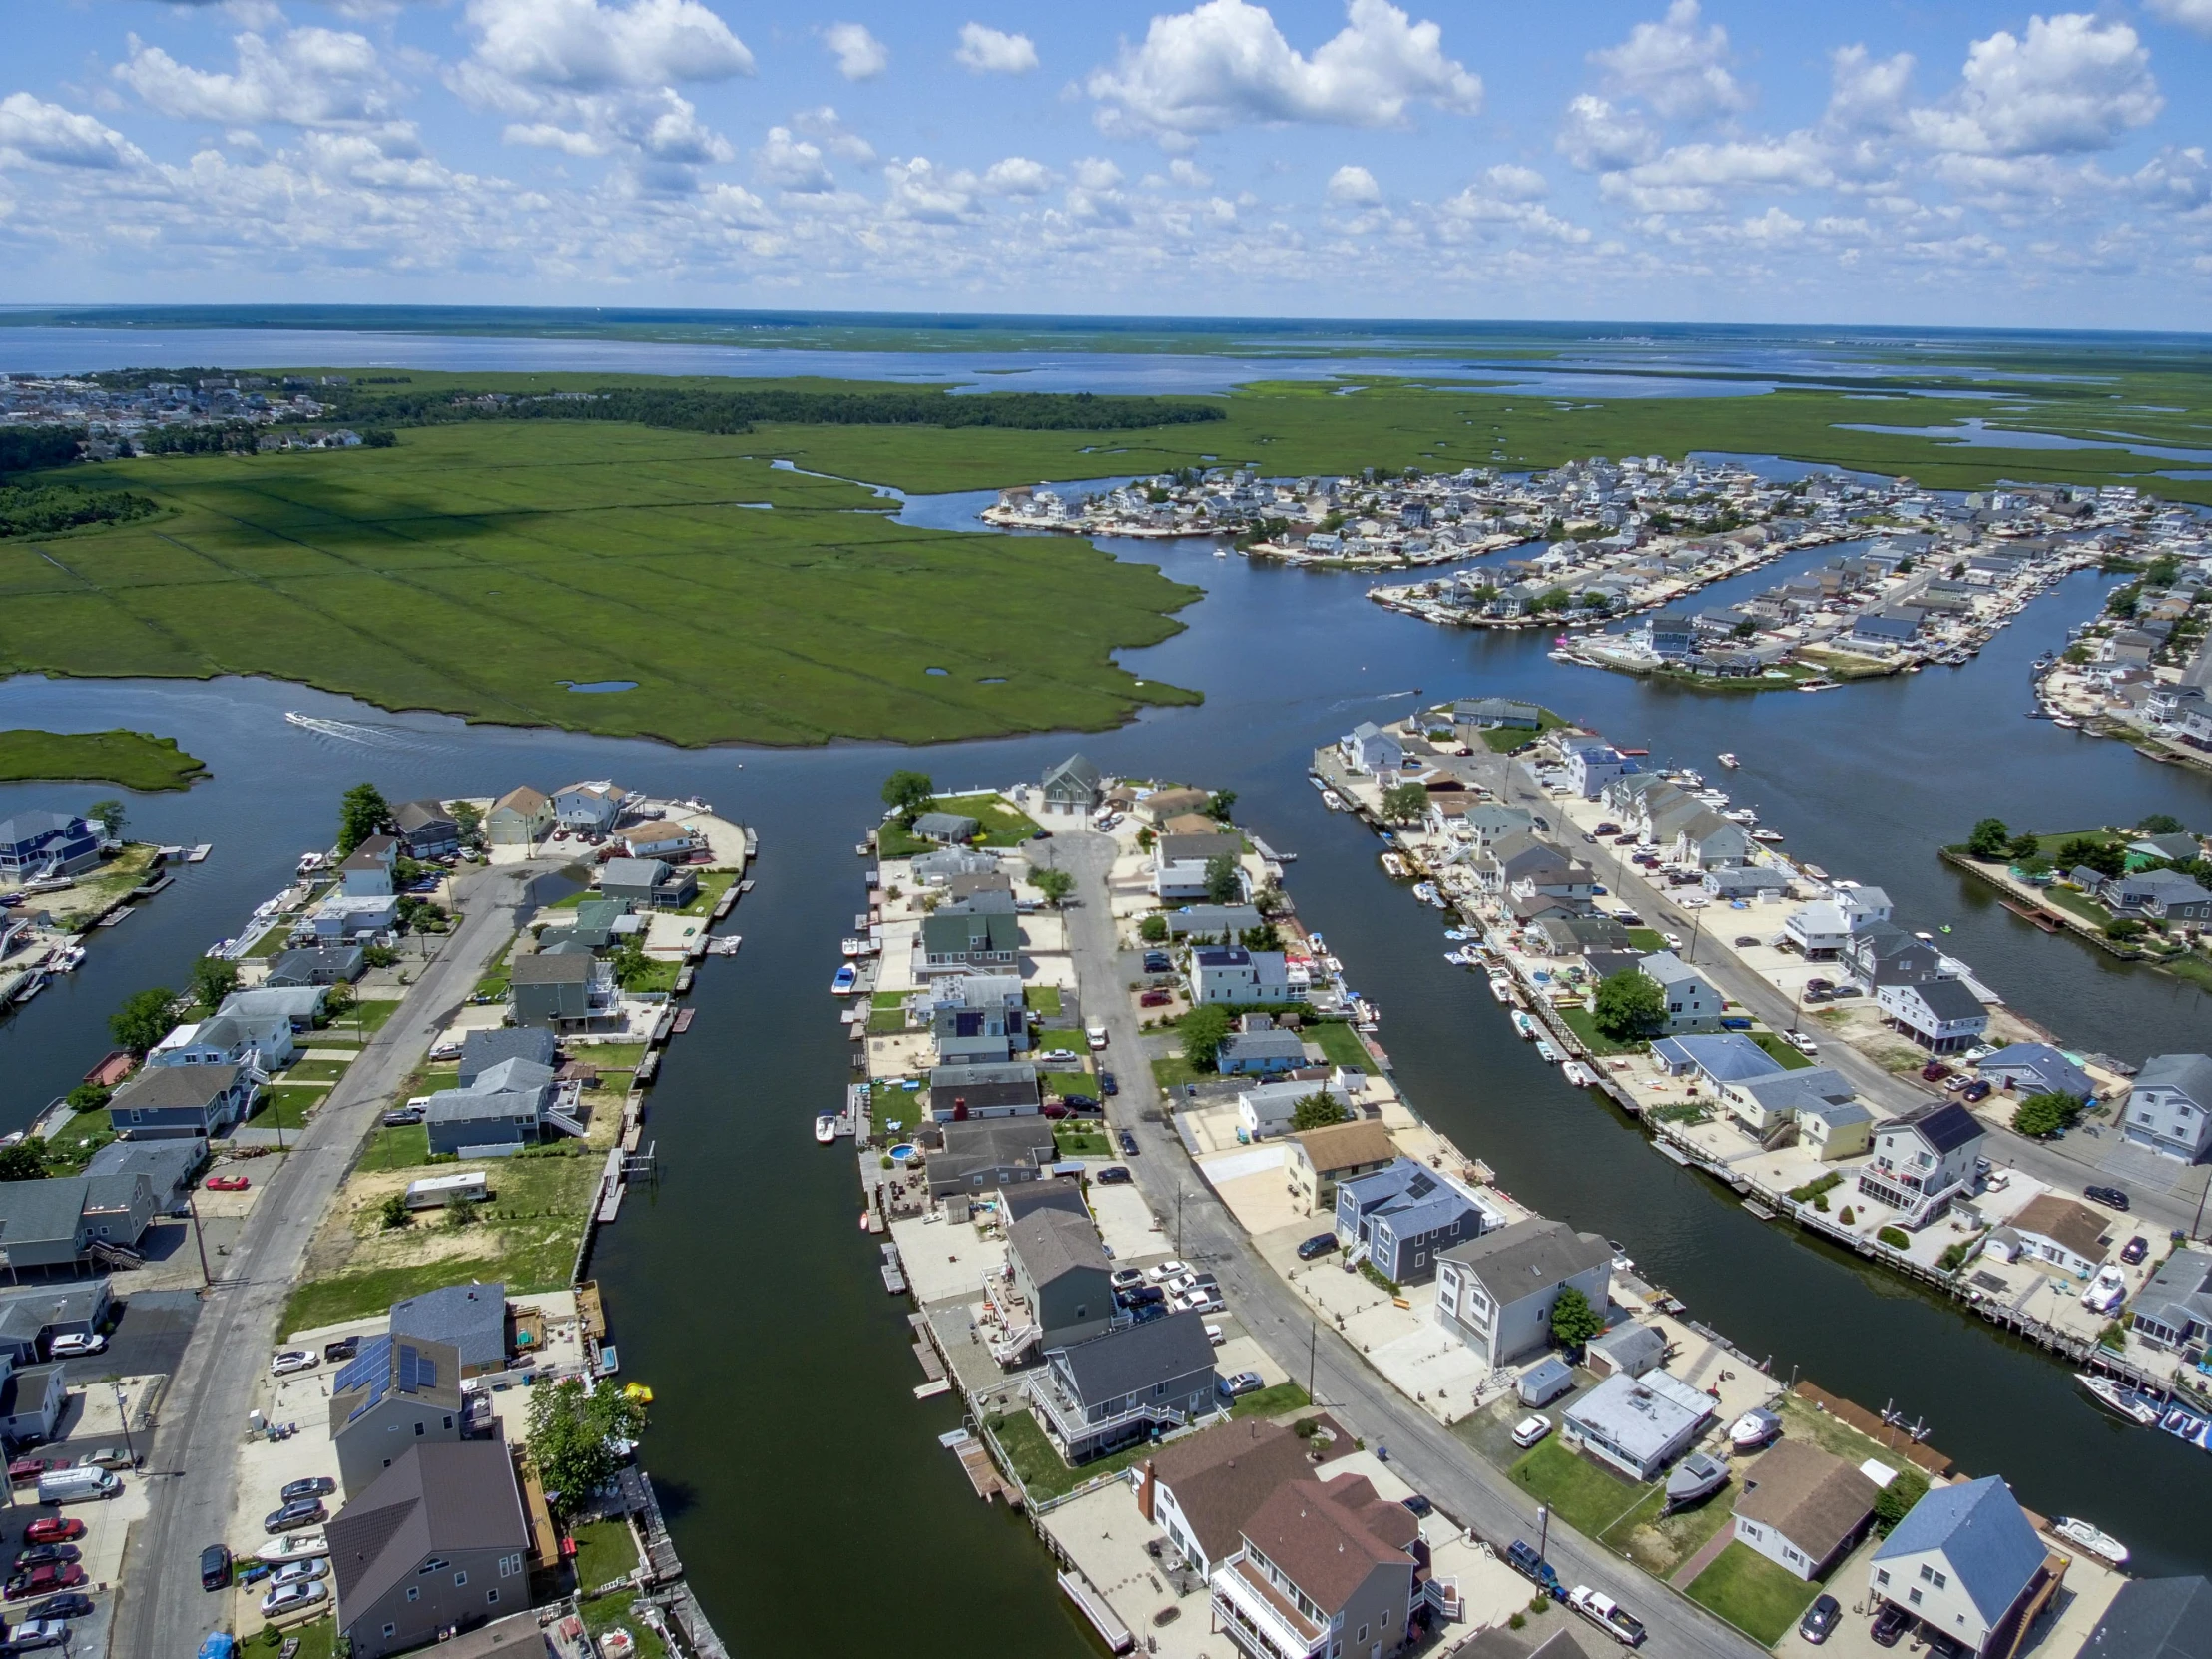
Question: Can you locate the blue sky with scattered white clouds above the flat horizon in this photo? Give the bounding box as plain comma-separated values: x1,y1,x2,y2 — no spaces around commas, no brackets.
0,0,2212,329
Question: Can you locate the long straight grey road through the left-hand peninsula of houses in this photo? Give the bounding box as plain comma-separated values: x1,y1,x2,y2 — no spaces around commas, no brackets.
113,862,557,1659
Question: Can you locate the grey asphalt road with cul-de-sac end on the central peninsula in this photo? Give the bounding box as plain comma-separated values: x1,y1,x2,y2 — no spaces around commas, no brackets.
1033,831,1763,1659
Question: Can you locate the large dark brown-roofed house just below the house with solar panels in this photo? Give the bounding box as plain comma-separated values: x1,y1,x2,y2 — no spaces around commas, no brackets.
327,1440,530,1659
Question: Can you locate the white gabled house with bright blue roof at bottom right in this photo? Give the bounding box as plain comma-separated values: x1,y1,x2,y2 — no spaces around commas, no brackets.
1867,1475,2064,1659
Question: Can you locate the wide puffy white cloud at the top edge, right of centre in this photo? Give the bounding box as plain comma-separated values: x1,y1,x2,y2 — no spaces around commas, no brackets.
1088,0,1482,137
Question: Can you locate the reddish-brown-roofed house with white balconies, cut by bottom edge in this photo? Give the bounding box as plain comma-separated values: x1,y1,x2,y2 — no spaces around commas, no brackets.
1208,1475,1426,1659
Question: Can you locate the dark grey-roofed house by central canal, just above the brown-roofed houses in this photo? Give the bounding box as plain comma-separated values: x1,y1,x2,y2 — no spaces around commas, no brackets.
1028,1312,1221,1462
